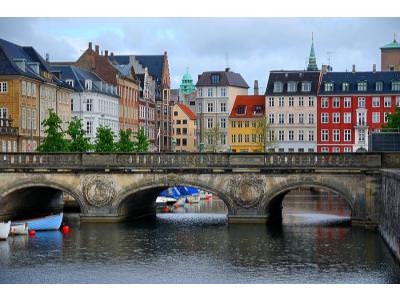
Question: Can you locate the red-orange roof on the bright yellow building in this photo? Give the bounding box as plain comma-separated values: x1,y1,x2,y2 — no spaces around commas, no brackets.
229,95,265,118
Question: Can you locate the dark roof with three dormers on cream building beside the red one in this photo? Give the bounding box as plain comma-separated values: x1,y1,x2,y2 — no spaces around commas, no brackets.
265,70,320,96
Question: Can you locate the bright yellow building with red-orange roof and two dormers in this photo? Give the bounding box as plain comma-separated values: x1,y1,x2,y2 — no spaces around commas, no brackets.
228,95,266,152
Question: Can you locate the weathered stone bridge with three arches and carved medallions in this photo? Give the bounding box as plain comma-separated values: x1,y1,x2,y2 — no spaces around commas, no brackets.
0,153,400,224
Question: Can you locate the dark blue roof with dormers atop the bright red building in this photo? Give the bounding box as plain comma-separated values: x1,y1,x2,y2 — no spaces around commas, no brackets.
319,71,400,95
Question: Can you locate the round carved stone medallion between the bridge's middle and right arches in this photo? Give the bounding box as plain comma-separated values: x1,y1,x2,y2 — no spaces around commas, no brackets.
229,174,266,208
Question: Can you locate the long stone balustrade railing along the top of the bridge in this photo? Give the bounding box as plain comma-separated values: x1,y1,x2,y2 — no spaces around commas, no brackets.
0,153,400,171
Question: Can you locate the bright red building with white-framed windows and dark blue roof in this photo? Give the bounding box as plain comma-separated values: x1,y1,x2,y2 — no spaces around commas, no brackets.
317,67,400,152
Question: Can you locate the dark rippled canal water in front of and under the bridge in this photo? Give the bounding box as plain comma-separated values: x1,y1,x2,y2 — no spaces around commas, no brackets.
0,191,400,283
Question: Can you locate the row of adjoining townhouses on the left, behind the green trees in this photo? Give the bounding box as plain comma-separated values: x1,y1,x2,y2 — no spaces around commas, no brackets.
0,39,172,152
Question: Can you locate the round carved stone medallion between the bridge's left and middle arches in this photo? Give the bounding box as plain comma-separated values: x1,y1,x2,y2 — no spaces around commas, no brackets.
82,175,117,207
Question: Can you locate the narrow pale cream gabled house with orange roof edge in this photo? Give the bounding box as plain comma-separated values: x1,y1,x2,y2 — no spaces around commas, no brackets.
172,103,197,152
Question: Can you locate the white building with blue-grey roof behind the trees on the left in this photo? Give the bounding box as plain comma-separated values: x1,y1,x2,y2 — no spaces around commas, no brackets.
52,64,119,142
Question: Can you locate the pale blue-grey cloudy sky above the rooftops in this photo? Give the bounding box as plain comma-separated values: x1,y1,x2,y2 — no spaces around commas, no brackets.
0,18,400,88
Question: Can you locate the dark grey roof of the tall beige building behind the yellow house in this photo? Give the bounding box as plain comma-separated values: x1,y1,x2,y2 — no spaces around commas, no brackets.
196,68,249,89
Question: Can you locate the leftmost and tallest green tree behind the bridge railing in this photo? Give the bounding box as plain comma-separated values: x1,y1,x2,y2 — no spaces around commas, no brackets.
38,109,68,152
